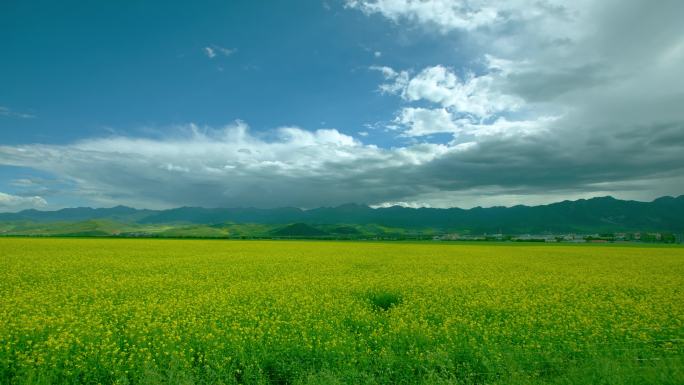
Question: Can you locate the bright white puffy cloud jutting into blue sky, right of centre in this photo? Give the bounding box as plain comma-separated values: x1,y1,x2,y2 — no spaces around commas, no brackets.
371,64,544,137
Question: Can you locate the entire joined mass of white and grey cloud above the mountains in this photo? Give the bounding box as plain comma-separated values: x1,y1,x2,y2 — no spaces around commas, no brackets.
0,0,684,209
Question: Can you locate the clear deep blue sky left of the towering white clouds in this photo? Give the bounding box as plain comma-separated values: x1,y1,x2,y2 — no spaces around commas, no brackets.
0,1,468,145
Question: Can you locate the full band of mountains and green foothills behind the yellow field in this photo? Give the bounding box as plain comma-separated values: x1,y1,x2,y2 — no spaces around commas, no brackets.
0,196,684,237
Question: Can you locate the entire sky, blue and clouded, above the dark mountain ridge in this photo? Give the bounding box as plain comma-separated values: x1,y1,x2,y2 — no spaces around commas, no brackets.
0,0,684,211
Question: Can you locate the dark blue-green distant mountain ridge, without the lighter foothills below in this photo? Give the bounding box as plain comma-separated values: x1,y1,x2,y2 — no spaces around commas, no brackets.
0,195,684,234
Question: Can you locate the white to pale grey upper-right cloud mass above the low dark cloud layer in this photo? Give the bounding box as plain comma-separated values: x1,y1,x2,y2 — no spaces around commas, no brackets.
358,0,684,158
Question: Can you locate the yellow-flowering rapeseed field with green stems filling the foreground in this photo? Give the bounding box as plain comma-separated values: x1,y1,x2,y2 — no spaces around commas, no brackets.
0,238,684,384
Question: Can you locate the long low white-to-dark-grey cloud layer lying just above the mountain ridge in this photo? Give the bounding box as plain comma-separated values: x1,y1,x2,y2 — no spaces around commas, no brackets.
0,118,684,208
